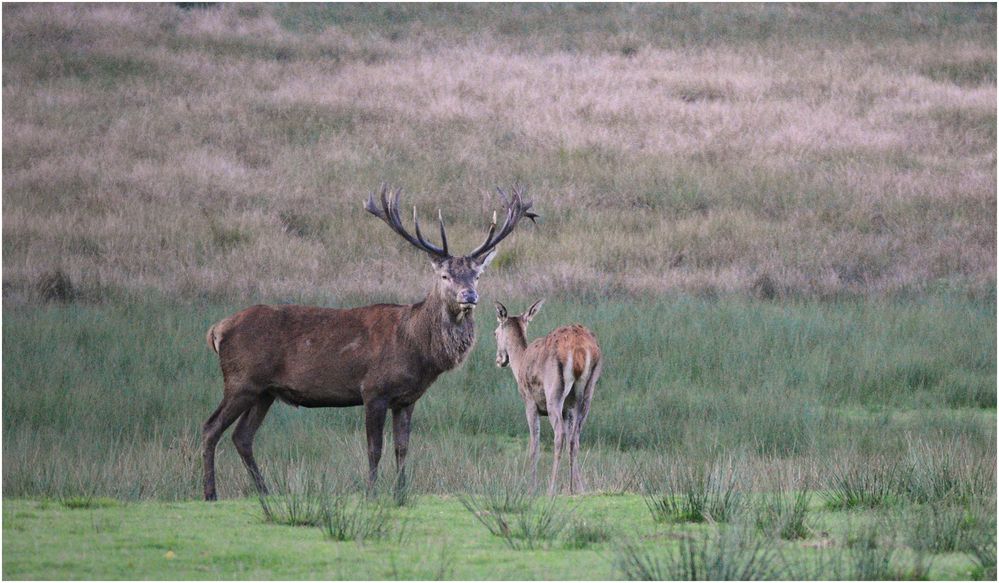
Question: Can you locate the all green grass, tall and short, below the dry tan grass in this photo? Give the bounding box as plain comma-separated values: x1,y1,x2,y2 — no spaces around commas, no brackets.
3,302,996,578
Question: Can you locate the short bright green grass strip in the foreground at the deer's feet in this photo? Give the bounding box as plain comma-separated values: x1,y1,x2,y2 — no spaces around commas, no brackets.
3,495,982,580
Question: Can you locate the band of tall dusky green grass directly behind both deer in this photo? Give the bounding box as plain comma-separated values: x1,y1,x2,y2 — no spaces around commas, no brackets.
3,298,996,506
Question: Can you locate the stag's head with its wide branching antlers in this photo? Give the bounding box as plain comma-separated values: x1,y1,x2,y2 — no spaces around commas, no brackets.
364,185,538,318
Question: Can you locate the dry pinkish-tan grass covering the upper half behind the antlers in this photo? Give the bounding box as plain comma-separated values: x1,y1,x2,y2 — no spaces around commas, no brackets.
3,5,996,300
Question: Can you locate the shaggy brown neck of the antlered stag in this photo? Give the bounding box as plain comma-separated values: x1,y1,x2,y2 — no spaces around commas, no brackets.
407,292,475,371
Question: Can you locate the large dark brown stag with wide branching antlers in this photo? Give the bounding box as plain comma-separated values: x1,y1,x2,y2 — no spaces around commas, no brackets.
202,186,538,500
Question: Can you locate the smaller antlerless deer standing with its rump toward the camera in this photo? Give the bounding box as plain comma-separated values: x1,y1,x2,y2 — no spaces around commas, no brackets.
496,300,603,495
